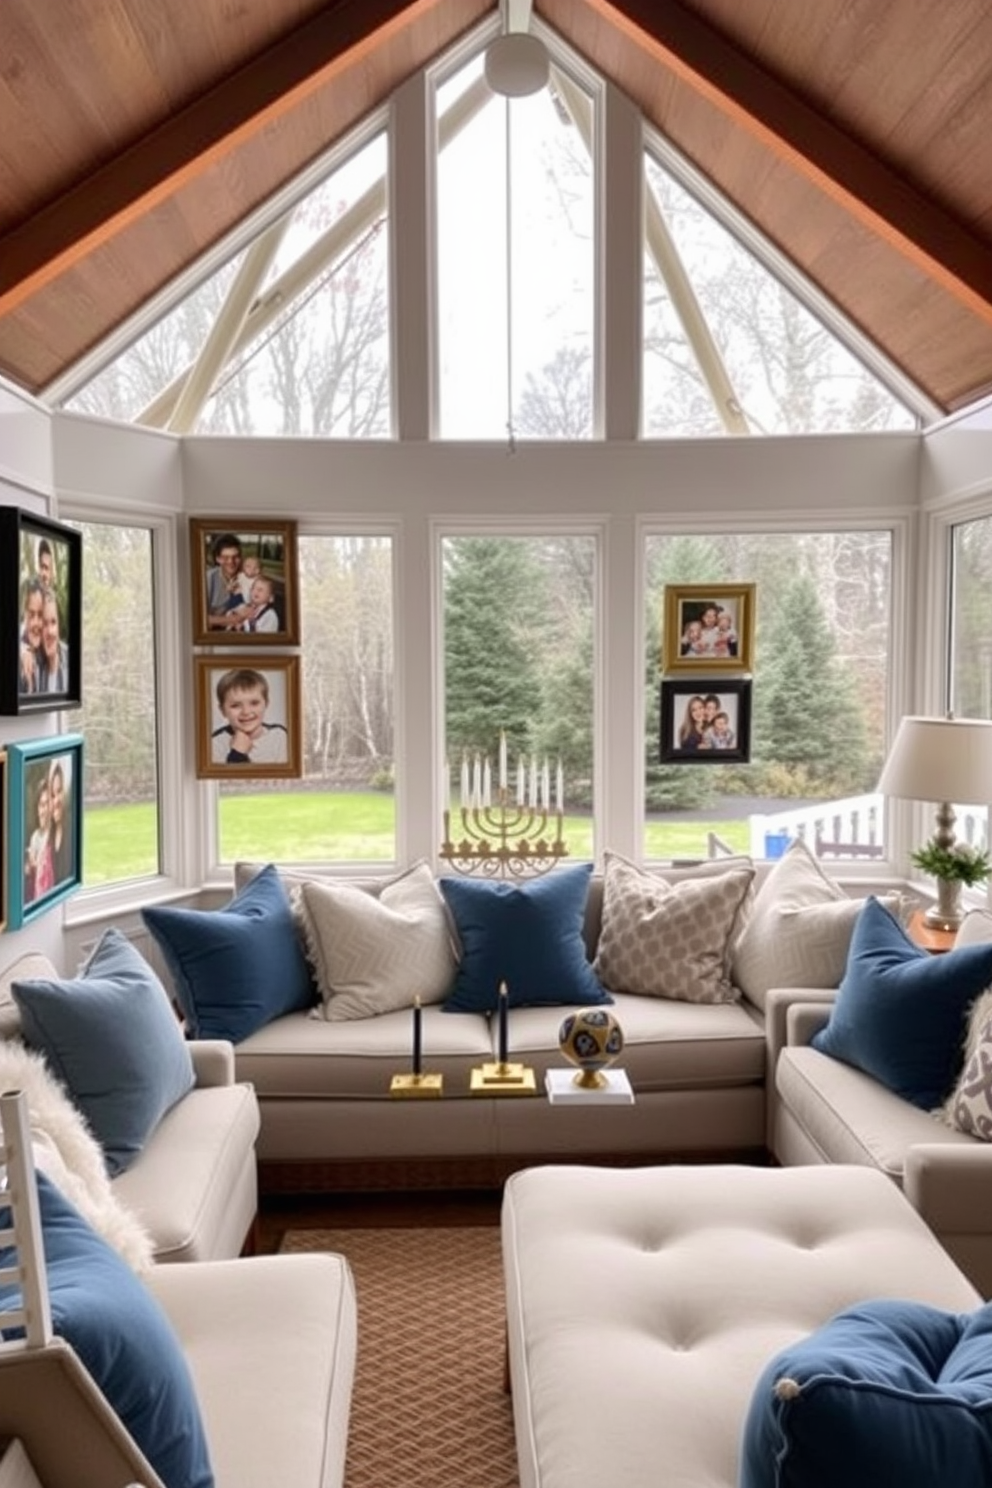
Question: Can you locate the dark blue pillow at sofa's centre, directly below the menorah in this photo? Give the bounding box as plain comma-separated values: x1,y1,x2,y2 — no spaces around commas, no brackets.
440,863,613,1013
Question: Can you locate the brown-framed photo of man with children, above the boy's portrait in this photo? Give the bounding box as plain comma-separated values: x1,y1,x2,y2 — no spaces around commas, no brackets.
189,518,299,646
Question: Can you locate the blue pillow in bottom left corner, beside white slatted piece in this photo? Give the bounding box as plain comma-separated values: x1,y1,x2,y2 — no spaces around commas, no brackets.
0,1173,214,1488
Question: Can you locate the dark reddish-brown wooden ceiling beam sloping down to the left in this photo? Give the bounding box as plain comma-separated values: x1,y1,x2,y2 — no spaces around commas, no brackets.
0,0,440,314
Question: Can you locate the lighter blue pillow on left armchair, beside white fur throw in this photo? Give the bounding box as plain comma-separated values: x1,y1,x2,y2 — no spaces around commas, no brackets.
12,930,195,1176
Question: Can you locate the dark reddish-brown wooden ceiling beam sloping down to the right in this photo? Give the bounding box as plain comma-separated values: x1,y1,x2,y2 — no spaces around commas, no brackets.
587,0,992,324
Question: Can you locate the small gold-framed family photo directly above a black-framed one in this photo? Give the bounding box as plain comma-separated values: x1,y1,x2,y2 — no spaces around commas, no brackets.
662,583,756,673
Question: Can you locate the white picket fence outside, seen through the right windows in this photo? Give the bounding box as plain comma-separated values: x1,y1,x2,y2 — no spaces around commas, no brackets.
748,792,988,860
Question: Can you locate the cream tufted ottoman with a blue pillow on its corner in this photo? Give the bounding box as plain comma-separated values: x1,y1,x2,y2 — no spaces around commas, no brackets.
503,1165,980,1488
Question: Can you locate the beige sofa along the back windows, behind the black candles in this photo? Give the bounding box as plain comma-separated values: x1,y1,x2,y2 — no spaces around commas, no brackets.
227,863,766,1192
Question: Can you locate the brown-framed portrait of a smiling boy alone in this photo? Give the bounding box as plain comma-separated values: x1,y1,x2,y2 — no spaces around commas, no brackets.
195,655,303,780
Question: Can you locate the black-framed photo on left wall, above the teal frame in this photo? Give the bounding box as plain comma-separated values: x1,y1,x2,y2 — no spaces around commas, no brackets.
0,506,82,716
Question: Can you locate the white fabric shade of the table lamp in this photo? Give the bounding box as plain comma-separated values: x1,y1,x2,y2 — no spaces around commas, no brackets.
879,717,992,806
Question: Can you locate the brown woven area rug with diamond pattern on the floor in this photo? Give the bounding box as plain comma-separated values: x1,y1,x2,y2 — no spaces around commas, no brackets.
280,1225,519,1488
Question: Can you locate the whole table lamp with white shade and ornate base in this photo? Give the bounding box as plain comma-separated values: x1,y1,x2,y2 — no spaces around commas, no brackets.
879,714,992,930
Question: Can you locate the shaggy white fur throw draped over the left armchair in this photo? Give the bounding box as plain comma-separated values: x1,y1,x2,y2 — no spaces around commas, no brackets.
0,1039,153,1272
